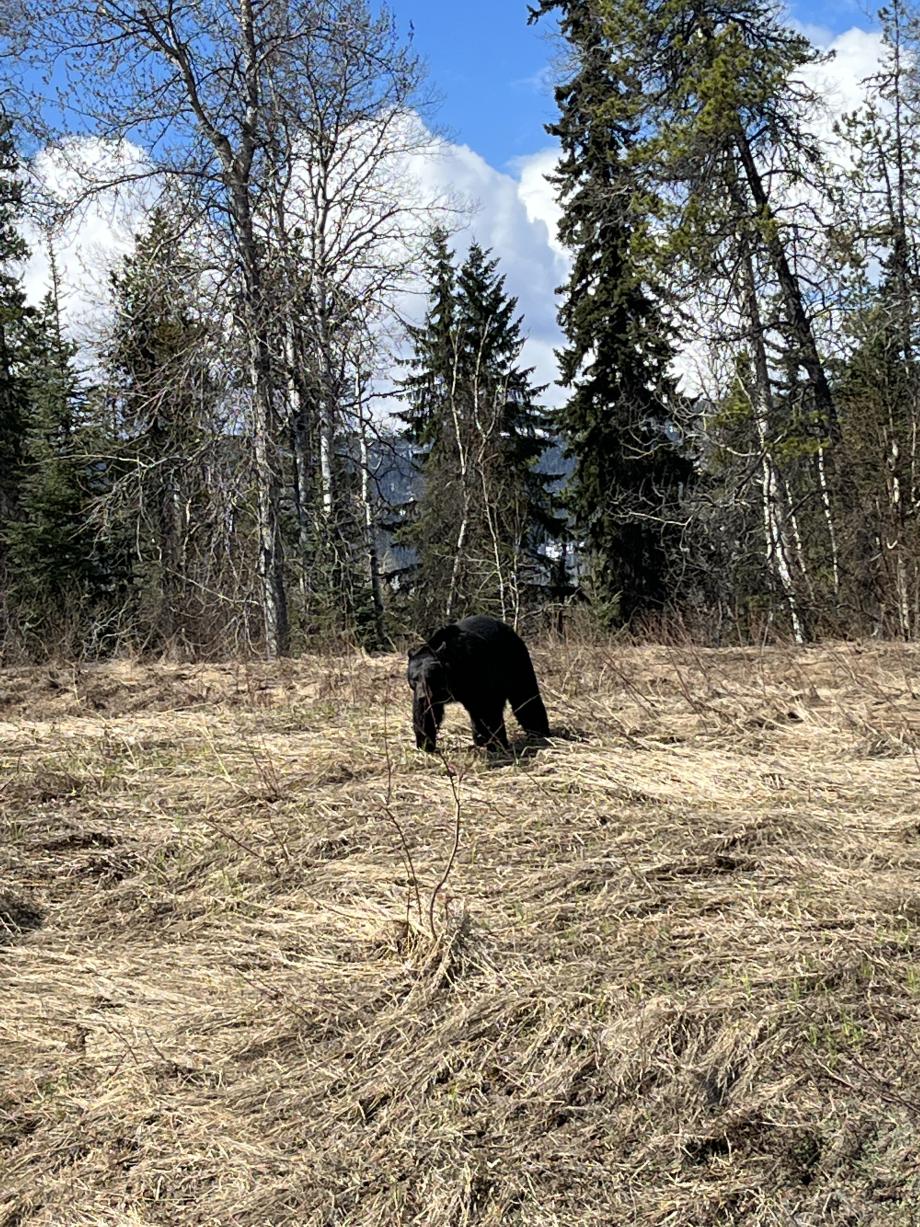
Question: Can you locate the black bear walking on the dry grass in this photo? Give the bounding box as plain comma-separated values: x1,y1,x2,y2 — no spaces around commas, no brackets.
408,614,550,752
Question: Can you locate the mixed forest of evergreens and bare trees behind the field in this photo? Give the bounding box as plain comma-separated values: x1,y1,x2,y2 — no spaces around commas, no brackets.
0,0,920,663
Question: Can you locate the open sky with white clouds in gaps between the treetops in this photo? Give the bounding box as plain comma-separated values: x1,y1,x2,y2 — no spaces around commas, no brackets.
26,0,878,402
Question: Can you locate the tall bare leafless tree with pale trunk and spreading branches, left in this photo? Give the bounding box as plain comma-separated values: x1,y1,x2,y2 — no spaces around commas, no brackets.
23,0,429,655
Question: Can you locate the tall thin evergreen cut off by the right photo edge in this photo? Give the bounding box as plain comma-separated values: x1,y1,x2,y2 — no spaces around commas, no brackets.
834,0,920,639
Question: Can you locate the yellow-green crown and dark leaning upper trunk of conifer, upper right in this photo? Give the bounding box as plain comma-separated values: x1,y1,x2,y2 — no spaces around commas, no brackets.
584,0,837,434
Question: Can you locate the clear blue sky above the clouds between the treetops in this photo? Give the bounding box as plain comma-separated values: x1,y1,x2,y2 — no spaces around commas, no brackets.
390,0,876,168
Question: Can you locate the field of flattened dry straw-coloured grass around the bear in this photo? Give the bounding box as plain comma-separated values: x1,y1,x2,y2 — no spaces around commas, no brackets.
0,645,920,1227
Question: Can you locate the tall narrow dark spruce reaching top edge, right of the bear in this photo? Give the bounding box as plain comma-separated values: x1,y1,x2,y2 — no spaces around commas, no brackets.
531,0,691,620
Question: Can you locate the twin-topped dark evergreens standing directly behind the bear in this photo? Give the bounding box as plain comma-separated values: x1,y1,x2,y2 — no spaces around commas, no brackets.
402,232,561,623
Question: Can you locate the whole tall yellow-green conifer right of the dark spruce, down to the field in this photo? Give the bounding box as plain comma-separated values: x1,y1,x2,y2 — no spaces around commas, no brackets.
599,0,846,639
